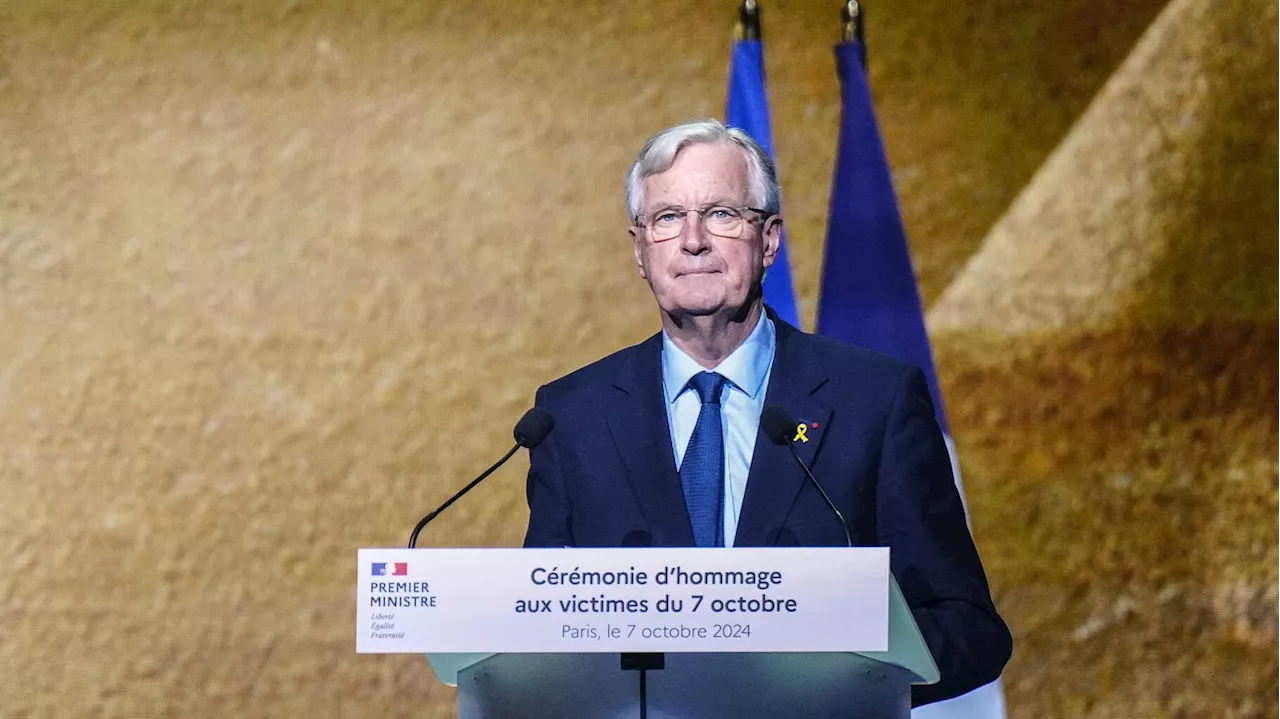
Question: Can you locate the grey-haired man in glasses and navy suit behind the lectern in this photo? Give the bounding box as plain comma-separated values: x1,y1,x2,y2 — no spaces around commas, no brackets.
525,120,1011,705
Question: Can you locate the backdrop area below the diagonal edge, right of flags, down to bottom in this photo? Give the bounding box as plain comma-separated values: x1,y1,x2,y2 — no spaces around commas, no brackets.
929,0,1280,718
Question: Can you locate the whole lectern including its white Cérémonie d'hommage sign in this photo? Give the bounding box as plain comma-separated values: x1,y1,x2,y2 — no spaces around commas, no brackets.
357,549,938,719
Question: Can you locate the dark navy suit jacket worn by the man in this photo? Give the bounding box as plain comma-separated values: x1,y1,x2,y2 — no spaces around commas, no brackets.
525,316,1012,705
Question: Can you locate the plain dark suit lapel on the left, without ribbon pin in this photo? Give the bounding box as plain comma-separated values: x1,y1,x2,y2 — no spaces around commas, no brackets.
605,334,694,546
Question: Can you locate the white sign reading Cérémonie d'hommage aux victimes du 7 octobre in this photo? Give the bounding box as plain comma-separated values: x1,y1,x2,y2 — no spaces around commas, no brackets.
356,548,890,654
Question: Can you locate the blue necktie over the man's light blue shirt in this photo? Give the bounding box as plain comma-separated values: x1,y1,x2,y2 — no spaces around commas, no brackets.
680,372,724,546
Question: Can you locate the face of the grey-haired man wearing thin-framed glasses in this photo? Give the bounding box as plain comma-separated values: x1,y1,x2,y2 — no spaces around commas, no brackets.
631,143,782,316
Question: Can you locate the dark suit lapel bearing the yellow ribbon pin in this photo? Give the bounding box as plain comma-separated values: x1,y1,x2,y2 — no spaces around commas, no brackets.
733,313,831,546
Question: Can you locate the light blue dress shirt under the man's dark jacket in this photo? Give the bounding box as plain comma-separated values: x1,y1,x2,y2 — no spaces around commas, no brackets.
662,313,777,546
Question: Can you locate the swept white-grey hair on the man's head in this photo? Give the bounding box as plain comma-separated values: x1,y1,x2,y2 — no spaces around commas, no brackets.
626,119,782,221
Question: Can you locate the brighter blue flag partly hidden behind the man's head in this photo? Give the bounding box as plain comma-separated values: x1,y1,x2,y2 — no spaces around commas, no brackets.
724,40,800,326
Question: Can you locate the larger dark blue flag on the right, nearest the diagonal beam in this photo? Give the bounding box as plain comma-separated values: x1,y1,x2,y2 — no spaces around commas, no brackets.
818,42,1005,719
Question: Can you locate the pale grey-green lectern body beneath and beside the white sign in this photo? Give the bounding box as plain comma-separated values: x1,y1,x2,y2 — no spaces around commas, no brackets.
428,580,938,719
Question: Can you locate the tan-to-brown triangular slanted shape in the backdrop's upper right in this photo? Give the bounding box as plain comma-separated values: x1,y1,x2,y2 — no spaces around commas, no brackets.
929,0,1280,333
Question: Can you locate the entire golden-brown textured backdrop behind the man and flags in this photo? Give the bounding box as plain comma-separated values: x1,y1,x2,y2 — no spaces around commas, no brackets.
0,0,1280,718
